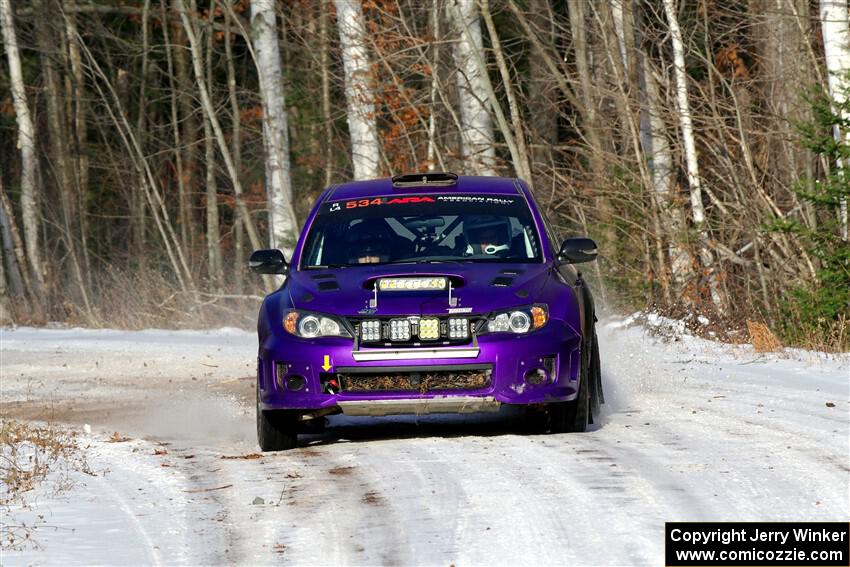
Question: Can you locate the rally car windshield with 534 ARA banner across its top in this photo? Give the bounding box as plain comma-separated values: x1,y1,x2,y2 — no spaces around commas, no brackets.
302,195,541,268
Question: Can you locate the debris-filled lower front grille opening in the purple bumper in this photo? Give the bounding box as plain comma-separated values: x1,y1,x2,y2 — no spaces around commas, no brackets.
328,366,493,394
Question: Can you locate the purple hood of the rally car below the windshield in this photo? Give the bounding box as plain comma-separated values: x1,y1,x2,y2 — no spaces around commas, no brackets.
287,262,549,316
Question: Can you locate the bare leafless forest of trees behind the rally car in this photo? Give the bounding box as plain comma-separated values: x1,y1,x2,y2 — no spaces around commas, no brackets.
0,0,850,350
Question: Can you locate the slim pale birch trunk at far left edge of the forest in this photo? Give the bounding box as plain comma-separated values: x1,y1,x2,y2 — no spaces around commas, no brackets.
0,0,44,297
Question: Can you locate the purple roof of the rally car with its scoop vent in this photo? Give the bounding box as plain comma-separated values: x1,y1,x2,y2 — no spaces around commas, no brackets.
327,175,519,201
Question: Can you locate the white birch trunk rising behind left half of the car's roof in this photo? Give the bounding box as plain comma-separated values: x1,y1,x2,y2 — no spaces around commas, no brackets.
335,0,381,179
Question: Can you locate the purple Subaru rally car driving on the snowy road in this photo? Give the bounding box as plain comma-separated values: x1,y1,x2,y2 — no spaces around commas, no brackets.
250,173,603,451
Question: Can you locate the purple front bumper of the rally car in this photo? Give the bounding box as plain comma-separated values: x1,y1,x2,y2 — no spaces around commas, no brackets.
257,320,582,415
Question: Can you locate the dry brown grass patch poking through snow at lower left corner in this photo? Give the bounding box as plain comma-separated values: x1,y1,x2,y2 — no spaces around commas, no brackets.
0,419,92,550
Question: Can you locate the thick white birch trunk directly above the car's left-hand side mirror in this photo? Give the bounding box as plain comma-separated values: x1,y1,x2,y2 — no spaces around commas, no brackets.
251,0,298,254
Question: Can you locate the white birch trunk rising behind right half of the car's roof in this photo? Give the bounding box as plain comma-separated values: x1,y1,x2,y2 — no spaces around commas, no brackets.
449,0,496,175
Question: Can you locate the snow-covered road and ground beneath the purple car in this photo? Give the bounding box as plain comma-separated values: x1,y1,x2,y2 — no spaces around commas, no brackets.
0,322,850,565
